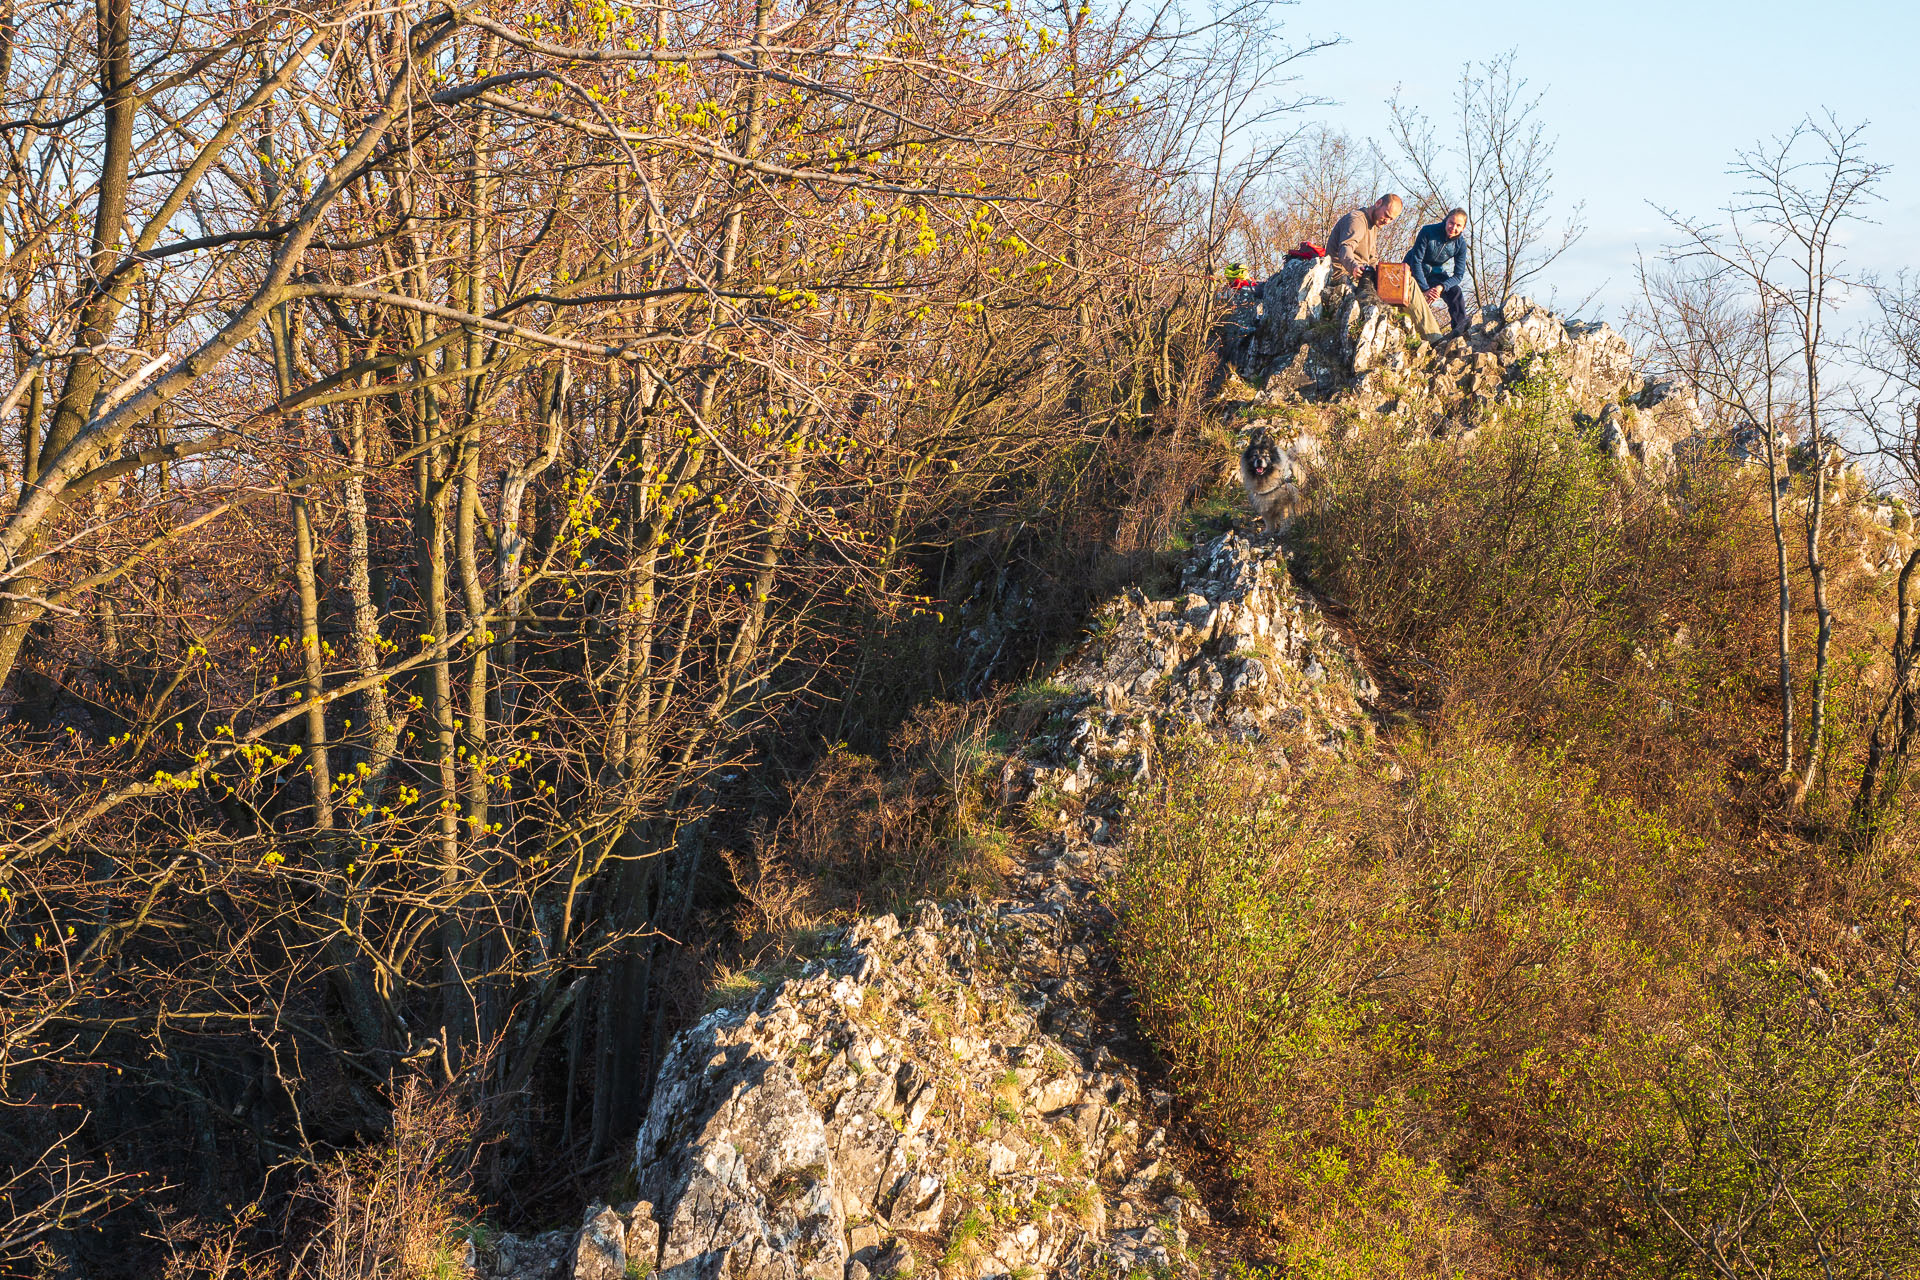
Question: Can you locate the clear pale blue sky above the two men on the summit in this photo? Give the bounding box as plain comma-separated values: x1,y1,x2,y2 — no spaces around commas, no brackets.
1283,0,1920,322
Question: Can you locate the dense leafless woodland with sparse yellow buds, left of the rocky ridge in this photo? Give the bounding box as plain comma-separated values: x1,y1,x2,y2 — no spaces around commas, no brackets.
0,0,1284,1268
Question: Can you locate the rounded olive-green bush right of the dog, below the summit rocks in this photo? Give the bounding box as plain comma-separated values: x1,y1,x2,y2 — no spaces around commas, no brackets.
1308,411,1726,712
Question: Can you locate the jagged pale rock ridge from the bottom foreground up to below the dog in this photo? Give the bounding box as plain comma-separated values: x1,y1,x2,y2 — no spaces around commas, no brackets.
472,533,1373,1280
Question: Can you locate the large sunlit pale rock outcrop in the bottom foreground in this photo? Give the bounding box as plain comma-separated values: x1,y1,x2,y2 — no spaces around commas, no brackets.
618,904,1139,1280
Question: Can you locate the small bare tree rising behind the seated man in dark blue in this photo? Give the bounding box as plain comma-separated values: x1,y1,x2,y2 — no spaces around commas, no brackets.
1382,50,1586,307
